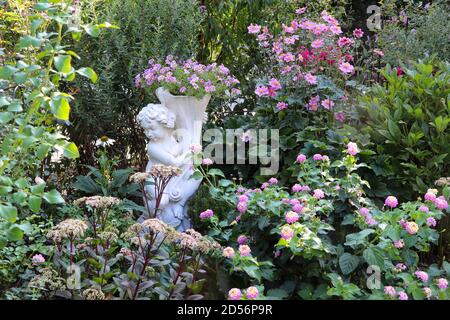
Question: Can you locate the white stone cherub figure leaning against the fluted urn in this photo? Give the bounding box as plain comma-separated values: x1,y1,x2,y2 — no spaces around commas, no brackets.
136,104,195,231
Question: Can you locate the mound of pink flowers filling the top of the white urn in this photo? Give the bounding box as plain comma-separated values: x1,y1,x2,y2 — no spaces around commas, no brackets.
135,55,240,96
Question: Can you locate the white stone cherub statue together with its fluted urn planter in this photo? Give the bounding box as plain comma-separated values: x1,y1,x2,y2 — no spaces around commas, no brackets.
137,88,211,231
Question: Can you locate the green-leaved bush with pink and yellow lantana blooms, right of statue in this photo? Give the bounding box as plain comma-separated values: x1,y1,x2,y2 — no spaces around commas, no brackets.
192,142,450,299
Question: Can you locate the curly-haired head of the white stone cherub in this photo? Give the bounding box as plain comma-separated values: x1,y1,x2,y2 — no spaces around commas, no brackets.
136,103,175,140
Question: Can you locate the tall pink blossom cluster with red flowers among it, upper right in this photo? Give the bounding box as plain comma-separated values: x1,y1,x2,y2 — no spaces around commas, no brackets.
248,8,364,118
